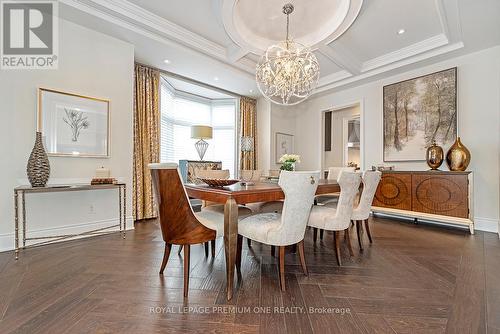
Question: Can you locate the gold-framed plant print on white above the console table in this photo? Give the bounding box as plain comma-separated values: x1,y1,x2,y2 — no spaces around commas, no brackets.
37,88,109,158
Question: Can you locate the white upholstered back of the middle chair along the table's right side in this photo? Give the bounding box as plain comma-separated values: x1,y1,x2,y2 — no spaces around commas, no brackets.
335,171,361,229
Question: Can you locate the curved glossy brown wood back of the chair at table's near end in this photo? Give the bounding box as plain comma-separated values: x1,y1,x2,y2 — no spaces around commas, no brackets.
148,163,216,245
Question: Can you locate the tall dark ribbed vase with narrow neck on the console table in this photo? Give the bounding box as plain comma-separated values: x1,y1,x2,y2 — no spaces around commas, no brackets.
26,132,50,187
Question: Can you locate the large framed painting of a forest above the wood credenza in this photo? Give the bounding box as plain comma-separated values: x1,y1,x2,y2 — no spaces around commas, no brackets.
383,67,458,162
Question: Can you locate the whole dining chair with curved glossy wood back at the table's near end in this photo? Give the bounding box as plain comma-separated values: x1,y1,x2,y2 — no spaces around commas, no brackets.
149,163,224,297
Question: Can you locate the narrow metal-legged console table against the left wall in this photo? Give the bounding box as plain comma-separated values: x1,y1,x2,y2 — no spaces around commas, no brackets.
14,183,127,260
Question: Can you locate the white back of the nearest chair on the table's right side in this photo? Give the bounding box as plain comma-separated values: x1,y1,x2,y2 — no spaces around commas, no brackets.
269,171,320,246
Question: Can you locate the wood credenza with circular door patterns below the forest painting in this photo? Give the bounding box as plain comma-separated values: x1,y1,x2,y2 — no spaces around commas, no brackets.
372,171,474,234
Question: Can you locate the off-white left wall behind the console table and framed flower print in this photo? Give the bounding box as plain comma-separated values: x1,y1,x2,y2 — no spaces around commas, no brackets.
0,20,134,251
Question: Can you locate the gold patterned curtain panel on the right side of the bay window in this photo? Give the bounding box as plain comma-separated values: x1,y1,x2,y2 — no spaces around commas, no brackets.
239,97,257,170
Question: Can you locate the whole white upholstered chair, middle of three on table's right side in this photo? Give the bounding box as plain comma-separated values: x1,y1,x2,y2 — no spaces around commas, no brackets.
308,172,361,266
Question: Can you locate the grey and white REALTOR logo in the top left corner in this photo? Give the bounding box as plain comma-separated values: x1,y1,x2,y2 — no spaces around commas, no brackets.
0,0,58,70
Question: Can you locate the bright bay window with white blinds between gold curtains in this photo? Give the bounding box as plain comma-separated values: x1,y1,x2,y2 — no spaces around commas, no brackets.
160,80,237,176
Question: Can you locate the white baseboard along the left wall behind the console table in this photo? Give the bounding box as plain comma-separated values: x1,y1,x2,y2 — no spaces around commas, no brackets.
0,216,134,252
